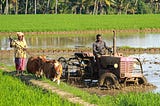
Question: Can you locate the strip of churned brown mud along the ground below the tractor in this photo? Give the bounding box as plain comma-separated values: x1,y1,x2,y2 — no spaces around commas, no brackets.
69,83,157,96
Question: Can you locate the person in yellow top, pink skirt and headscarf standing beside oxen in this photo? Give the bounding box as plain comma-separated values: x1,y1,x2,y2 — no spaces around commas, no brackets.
9,32,27,75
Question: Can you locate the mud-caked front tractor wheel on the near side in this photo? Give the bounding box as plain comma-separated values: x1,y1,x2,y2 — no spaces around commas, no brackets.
99,73,119,89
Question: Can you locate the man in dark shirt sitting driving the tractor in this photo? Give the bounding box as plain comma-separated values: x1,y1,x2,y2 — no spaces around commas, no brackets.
93,34,110,69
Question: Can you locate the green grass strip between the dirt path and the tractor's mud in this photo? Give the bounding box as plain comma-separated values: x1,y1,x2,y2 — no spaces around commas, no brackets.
47,82,160,106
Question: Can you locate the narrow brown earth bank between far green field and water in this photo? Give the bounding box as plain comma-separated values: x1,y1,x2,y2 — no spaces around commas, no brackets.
0,28,160,35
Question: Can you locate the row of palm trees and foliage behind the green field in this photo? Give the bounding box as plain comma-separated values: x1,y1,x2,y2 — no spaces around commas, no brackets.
0,0,160,15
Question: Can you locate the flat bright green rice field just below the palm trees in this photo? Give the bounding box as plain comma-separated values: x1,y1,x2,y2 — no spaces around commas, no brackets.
0,15,160,32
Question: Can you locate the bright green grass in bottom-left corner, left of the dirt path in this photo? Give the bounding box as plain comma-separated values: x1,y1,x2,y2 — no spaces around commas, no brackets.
0,70,78,106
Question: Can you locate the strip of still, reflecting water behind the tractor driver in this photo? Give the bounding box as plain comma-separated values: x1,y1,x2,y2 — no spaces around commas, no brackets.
0,34,160,50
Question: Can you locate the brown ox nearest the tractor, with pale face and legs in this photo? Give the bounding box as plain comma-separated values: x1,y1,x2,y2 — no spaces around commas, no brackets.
42,60,62,85
